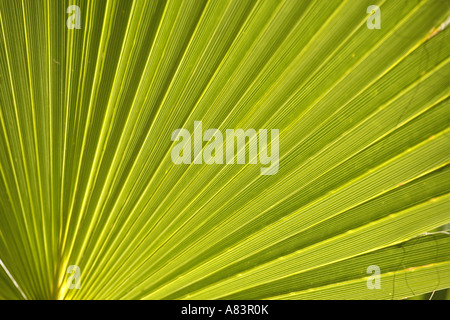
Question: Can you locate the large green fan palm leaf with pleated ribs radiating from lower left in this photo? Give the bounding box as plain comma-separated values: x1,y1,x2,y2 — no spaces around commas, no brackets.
0,0,450,299
